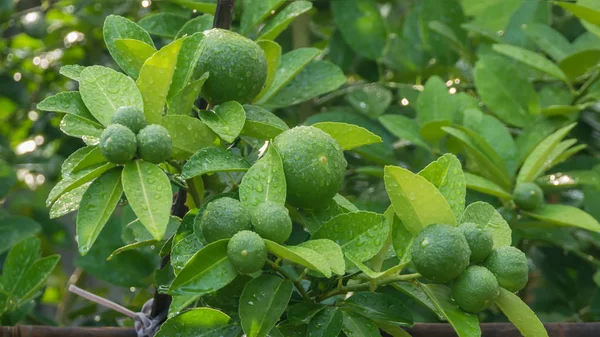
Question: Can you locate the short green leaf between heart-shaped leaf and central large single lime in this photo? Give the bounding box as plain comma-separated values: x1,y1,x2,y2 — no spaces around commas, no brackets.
240,105,289,139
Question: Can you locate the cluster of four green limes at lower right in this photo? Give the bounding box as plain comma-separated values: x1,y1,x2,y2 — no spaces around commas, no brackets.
411,223,529,313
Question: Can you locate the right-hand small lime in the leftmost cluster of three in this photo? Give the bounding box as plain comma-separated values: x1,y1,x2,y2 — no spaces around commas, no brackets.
137,124,173,164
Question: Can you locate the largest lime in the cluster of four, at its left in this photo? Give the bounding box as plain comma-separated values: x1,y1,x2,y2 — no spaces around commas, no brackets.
410,224,471,283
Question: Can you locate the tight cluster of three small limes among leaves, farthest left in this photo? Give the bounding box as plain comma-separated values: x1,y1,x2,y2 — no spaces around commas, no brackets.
99,106,173,164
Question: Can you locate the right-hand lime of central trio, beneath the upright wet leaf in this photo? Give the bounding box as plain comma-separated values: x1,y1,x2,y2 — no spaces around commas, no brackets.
252,201,292,243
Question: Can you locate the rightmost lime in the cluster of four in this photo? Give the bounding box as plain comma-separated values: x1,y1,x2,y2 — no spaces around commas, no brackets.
482,247,529,292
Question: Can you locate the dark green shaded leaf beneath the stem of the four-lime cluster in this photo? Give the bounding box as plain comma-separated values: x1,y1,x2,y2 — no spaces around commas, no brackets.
342,292,413,326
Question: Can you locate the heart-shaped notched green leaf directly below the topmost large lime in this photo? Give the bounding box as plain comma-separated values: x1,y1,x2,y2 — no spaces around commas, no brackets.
198,101,246,143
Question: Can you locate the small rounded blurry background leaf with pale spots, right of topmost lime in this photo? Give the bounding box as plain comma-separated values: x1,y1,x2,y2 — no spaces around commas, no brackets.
346,83,393,118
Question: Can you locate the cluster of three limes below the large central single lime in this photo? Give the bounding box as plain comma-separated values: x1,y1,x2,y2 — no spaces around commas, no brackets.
196,197,292,274
